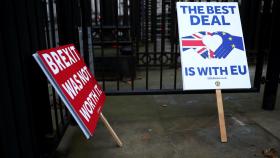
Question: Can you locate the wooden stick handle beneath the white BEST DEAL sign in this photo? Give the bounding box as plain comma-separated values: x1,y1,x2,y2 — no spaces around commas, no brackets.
216,89,227,143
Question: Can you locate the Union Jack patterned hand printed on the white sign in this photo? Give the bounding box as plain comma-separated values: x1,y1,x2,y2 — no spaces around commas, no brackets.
181,31,215,59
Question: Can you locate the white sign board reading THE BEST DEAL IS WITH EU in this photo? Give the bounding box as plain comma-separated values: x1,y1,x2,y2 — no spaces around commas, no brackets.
177,2,251,90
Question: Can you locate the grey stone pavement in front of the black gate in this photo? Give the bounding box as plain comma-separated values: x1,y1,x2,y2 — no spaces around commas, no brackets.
54,80,280,158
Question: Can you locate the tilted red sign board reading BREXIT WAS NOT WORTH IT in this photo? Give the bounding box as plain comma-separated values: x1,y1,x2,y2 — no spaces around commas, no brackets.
33,44,105,138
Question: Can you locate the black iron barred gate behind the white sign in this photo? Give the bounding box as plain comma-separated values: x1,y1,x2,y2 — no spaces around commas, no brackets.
83,0,272,95
